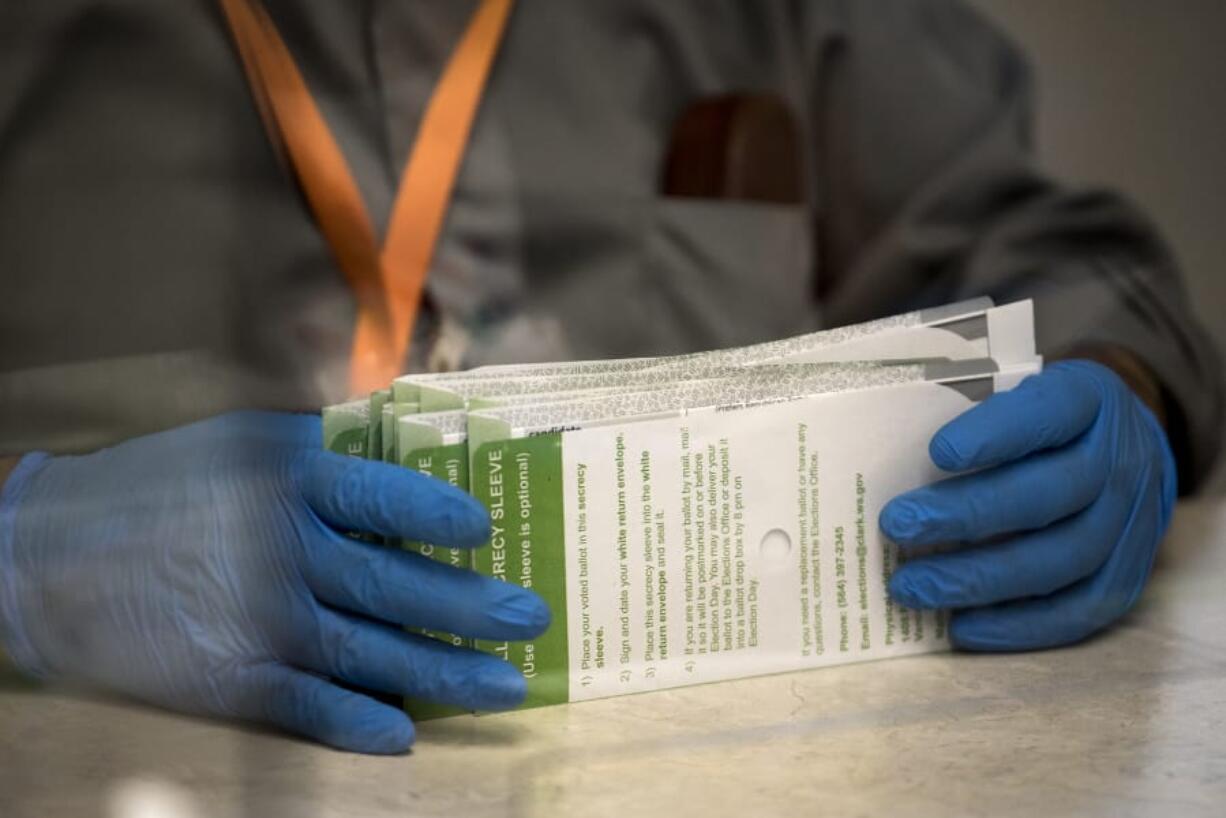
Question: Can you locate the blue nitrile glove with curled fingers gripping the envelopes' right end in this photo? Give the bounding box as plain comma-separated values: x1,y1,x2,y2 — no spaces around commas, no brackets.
880,361,1176,650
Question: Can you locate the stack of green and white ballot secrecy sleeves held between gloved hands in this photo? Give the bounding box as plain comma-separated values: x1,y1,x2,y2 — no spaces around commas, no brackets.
324,300,1041,716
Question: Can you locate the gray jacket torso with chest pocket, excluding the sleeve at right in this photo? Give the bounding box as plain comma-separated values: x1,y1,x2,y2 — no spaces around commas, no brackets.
0,0,833,450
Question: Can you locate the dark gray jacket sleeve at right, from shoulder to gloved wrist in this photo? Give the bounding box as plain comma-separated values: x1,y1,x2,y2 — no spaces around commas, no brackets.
802,0,1222,493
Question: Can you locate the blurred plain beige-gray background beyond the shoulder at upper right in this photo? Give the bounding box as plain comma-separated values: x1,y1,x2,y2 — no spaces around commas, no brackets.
972,0,1226,494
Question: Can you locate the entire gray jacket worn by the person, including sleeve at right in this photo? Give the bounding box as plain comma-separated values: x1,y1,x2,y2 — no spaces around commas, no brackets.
0,0,1222,489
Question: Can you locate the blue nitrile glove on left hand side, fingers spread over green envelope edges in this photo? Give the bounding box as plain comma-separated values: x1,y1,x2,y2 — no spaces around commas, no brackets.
0,413,549,753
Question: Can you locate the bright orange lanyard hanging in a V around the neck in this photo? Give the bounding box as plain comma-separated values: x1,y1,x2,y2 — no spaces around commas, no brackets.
221,0,514,394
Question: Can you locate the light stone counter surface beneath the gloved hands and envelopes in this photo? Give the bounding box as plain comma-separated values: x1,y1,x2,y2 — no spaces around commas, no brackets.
0,503,1226,818
